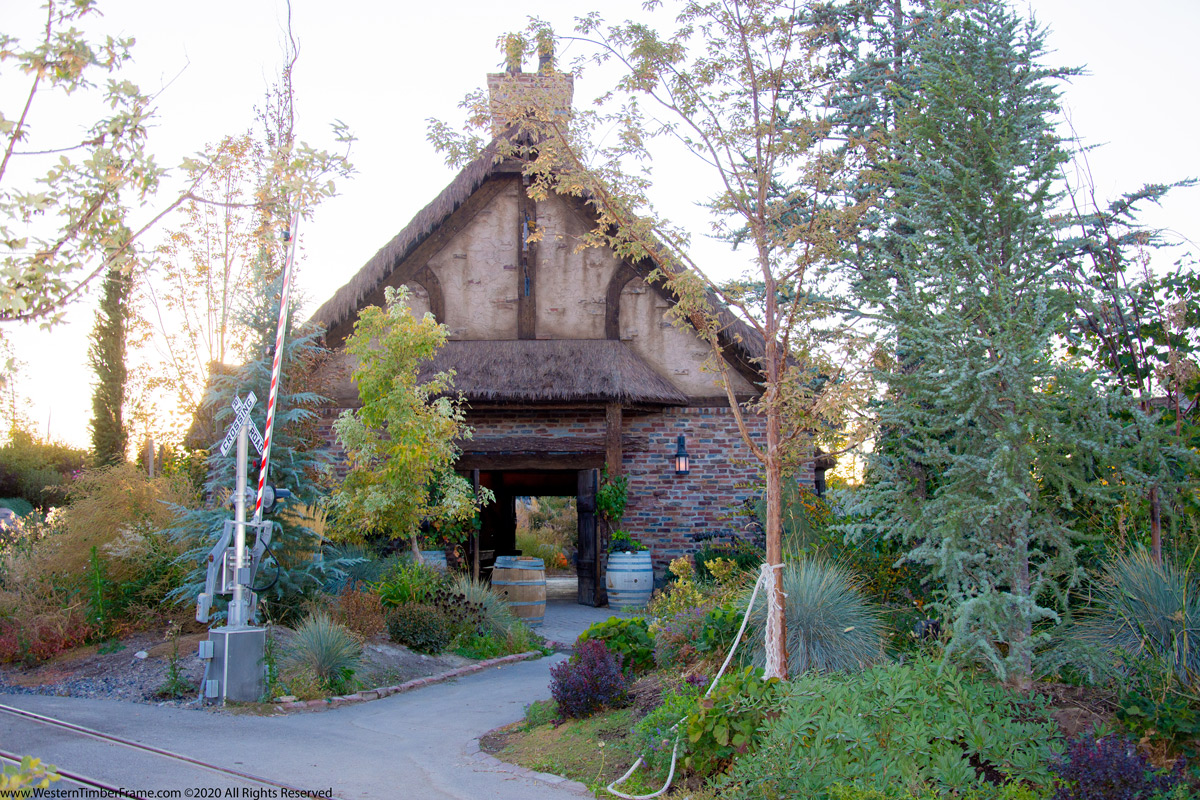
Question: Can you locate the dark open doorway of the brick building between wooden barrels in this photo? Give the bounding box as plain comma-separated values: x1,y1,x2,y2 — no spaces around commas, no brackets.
479,469,608,606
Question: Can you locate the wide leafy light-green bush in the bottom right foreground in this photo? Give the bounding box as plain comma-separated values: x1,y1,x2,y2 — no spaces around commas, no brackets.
722,657,1063,800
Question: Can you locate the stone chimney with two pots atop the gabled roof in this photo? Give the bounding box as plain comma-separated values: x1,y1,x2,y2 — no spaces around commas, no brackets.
487,40,575,136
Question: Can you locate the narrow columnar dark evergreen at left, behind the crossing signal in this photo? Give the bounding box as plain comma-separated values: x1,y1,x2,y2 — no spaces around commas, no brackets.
88,265,133,467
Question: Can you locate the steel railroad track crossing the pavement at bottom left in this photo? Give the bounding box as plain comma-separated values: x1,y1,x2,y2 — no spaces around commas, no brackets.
0,704,337,800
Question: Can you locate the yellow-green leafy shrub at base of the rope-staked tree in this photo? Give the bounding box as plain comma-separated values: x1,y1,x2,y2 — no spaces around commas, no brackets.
684,667,780,775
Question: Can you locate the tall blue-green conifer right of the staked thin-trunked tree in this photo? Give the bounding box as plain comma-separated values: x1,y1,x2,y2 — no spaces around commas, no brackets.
852,0,1124,687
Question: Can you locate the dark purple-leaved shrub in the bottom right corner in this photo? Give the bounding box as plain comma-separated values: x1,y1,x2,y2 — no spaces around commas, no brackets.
1054,735,1183,800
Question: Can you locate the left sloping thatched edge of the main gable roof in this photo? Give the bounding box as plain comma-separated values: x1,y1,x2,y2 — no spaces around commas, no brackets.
312,142,500,331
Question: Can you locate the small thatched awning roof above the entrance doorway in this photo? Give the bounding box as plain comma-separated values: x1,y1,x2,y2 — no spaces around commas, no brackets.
426,339,688,405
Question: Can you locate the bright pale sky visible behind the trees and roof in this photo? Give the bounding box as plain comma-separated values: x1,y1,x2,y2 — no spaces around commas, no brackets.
0,0,1200,446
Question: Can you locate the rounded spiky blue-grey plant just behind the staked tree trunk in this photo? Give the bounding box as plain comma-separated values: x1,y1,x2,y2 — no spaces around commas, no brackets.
743,559,883,675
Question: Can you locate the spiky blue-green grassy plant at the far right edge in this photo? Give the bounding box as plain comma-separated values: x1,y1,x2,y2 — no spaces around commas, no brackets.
1072,551,1200,686
